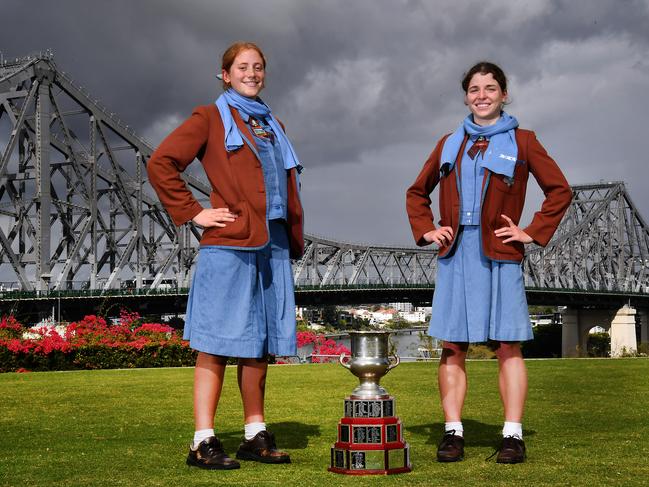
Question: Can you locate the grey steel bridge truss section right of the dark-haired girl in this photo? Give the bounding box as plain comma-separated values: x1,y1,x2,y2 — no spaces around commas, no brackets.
524,182,649,294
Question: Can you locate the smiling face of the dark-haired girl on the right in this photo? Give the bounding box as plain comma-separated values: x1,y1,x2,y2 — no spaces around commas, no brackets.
464,73,507,125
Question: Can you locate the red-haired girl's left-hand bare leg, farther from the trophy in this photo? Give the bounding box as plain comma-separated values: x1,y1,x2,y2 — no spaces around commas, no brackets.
194,352,227,431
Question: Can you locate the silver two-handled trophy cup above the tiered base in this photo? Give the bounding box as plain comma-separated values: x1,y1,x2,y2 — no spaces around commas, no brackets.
338,331,400,399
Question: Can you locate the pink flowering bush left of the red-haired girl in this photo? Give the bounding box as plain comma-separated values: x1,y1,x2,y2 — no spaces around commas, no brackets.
0,310,195,372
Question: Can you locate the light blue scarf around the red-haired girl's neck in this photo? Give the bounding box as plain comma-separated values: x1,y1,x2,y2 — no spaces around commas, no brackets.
216,88,301,169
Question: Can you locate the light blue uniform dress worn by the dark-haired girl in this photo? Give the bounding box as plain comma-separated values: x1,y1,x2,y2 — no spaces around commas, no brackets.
428,135,532,343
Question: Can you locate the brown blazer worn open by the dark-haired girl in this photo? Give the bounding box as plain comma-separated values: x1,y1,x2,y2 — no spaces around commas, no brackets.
406,129,572,262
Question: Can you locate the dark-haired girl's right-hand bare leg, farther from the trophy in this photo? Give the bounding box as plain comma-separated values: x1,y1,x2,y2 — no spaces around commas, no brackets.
496,342,527,423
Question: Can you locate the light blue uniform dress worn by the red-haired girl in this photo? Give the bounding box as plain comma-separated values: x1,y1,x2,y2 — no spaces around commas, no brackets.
184,112,297,358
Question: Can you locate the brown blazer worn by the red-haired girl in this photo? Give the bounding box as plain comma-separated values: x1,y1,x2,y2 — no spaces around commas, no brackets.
147,104,304,258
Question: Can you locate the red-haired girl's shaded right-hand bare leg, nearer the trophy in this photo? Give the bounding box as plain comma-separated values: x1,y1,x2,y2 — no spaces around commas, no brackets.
237,358,268,424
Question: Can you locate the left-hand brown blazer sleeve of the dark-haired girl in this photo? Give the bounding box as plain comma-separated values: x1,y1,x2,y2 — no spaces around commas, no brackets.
406,137,446,246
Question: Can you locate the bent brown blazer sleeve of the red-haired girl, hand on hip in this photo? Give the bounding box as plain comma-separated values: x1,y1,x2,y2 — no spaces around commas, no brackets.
147,107,209,226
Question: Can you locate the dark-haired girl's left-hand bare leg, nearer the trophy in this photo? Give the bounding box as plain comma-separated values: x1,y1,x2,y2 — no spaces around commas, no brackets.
438,342,469,422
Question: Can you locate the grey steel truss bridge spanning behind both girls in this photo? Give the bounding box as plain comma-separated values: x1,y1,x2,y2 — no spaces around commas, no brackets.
0,52,649,324
